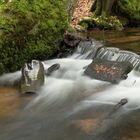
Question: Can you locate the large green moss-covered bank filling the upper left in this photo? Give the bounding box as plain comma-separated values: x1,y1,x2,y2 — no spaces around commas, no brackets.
0,0,68,74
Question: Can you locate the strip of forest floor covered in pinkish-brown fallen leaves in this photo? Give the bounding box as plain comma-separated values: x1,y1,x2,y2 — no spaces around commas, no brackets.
71,0,93,27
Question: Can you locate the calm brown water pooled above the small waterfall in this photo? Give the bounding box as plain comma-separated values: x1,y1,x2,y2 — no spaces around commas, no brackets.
84,28,140,54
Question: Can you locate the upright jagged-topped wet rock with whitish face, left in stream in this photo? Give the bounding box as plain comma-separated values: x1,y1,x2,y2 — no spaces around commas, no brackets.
20,60,45,94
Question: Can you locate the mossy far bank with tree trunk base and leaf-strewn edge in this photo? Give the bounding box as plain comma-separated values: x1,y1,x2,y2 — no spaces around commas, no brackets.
80,0,140,30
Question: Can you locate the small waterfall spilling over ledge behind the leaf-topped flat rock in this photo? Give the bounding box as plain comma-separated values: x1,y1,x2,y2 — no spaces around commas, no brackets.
74,40,140,71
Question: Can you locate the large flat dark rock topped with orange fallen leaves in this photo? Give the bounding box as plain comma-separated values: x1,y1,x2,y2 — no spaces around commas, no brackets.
84,58,133,83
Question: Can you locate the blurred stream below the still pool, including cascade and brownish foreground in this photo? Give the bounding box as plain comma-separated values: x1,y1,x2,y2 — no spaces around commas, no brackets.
0,28,140,140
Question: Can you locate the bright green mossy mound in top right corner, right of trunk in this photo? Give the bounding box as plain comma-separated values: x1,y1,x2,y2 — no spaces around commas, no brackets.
118,0,140,23
